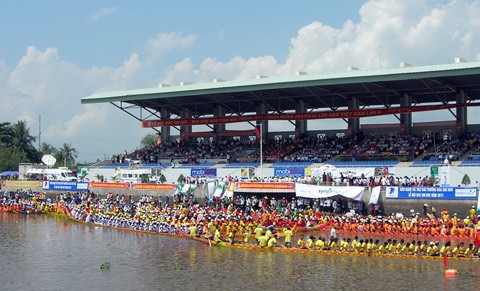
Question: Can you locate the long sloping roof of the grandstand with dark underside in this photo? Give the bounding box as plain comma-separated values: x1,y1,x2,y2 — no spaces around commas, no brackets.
81,59,480,116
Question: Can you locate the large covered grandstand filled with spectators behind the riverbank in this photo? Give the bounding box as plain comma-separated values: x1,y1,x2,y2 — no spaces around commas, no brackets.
81,58,480,186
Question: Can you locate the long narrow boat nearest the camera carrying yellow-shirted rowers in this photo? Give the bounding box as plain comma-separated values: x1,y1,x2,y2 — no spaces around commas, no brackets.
179,229,480,262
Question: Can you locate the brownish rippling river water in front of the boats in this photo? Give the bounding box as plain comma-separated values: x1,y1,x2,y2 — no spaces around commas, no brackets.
0,212,480,290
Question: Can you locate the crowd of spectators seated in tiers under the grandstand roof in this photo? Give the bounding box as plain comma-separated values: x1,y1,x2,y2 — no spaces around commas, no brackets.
106,132,480,165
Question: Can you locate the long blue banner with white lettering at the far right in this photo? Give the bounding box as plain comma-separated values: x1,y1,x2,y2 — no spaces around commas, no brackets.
385,187,478,200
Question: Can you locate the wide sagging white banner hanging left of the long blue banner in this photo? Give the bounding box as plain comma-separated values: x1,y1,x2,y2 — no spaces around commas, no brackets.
295,183,365,201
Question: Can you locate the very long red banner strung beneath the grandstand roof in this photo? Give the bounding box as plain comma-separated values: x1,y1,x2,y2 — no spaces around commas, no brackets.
142,103,480,128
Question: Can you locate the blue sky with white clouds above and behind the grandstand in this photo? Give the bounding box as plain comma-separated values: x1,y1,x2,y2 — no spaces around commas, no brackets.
0,0,480,162
